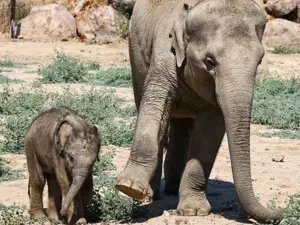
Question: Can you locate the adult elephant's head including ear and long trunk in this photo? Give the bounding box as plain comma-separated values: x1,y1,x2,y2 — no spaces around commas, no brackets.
170,0,283,221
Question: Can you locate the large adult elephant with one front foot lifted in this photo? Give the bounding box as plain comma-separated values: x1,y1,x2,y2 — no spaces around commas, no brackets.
116,0,283,221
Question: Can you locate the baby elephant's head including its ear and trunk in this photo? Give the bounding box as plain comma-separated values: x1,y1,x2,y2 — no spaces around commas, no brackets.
54,115,101,216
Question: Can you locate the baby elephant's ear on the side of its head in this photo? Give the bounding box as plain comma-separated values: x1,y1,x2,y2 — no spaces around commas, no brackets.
54,117,73,155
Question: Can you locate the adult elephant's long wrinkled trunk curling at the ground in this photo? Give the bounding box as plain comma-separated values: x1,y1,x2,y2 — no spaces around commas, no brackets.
216,68,283,222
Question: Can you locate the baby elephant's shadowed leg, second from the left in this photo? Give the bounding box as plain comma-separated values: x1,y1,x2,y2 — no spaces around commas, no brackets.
47,176,62,220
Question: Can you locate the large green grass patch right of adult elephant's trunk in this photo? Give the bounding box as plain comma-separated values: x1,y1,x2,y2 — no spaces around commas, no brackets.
252,78,300,138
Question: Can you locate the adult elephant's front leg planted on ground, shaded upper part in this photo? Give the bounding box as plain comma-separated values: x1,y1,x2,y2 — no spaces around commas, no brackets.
177,106,225,216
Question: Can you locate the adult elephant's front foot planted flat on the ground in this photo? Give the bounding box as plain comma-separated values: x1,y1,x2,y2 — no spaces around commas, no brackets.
177,197,211,216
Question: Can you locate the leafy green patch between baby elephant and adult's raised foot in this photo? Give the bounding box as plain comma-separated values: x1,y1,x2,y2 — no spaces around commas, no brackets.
86,150,138,222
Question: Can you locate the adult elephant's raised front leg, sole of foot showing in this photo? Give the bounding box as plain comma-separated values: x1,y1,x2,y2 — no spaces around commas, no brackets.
115,74,172,201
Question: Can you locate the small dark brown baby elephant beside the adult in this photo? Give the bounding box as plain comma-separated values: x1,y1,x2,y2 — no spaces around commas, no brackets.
25,107,101,224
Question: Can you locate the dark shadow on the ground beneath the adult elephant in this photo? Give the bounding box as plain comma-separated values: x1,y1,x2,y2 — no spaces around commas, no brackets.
134,180,251,223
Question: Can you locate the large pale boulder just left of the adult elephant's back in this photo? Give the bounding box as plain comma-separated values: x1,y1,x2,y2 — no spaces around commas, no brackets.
77,4,129,43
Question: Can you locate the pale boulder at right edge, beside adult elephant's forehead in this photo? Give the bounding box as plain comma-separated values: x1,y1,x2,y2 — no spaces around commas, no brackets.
264,19,300,48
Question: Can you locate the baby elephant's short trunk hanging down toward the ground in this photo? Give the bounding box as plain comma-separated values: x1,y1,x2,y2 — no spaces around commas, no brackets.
60,170,87,216
